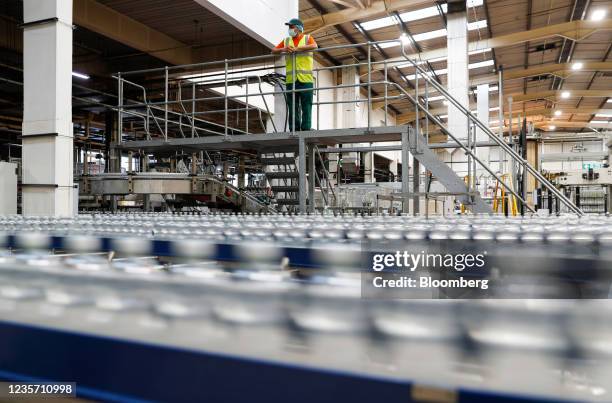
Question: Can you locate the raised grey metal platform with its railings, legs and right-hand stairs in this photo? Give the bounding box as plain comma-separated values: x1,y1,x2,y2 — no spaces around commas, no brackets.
111,41,582,215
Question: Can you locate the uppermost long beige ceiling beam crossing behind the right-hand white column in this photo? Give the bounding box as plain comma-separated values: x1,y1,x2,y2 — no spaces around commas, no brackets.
374,19,612,74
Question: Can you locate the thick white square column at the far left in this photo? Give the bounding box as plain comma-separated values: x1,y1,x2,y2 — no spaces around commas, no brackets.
23,0,76,217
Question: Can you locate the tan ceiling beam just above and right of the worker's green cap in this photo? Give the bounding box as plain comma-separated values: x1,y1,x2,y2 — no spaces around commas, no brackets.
304,0,434,33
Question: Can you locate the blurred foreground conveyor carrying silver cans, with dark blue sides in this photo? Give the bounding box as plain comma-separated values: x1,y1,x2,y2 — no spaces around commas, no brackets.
0,214,612,403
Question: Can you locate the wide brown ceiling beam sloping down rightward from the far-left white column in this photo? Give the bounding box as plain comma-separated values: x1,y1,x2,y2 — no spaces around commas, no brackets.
73,0,194,65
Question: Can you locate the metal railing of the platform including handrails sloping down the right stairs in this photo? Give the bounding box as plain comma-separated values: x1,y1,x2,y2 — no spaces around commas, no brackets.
114,40,582,215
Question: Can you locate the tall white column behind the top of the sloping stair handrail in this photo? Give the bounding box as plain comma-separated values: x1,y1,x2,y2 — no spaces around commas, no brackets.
446,0,469,139
